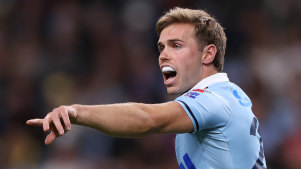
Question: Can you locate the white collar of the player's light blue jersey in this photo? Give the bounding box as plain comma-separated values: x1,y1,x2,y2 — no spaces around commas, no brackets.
192,73,229,90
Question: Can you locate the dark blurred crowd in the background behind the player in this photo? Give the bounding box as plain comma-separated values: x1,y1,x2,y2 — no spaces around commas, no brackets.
0,0,301,169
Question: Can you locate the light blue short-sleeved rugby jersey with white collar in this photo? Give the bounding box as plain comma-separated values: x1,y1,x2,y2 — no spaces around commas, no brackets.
175,73,266,169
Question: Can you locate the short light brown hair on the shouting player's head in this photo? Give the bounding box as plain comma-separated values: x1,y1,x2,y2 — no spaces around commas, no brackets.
156,7,227,72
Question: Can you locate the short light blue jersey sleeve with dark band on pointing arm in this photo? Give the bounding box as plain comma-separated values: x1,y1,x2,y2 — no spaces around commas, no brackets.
175,91,231,132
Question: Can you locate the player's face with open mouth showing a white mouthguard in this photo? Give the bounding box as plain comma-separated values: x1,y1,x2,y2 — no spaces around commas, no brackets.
158,23,202,94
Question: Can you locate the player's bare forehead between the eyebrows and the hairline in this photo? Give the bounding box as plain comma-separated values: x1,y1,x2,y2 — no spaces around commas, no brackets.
159,23,194,42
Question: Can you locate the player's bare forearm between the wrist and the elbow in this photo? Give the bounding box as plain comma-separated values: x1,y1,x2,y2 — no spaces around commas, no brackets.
72,103,156,137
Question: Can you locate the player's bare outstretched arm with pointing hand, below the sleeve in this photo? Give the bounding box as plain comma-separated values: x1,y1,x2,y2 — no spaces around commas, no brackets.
27,102,193,144
